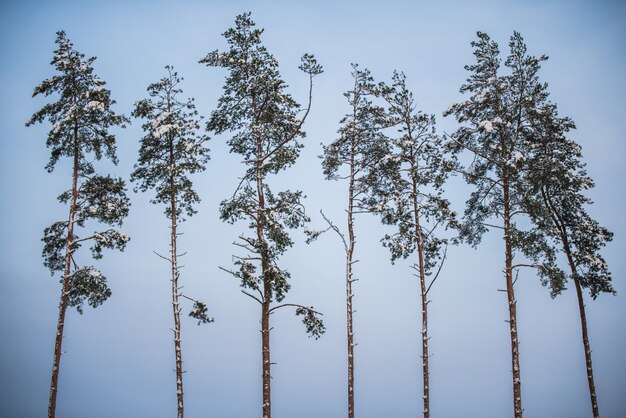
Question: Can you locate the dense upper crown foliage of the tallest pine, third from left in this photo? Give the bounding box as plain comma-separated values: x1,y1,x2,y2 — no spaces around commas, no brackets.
200,13,322,175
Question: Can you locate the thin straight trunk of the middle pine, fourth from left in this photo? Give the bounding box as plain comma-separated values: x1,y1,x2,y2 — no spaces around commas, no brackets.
346,146,355,418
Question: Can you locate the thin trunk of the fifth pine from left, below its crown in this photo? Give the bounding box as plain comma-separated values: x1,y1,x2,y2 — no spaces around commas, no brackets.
411,172,430,418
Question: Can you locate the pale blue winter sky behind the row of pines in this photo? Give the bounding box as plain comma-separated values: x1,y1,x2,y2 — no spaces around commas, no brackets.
0,0,626,418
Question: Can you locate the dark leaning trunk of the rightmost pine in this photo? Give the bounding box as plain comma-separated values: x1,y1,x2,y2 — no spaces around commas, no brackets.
541,189,600,418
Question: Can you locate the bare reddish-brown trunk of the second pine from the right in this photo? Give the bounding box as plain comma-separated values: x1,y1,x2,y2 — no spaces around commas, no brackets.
502,173,523,418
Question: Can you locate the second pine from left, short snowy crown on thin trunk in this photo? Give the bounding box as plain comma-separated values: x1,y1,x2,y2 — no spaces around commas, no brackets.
131,66,213,418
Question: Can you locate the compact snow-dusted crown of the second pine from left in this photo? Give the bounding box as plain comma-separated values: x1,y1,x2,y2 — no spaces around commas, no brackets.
131,66,209,220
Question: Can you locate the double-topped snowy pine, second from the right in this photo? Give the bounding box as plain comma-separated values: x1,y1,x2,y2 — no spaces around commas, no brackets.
444,32,564,418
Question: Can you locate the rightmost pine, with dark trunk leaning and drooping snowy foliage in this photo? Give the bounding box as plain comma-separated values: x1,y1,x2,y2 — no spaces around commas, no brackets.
526,90,615,417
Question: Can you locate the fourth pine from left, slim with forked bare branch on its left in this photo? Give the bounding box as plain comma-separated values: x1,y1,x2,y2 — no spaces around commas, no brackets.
307,64,388,418
